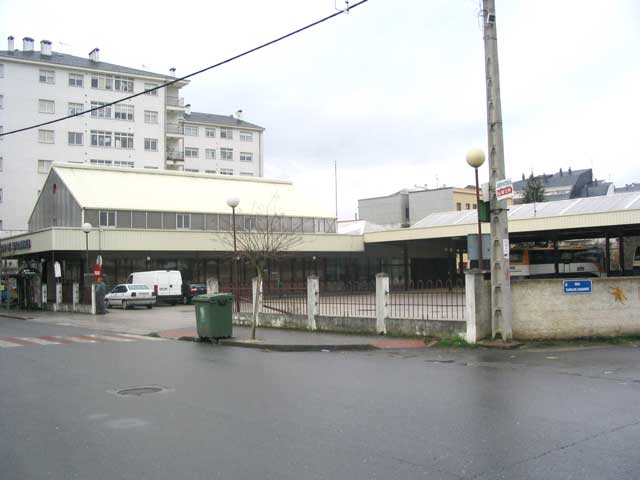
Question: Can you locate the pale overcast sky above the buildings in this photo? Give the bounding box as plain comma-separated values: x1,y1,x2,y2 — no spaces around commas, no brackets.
0,0,640,219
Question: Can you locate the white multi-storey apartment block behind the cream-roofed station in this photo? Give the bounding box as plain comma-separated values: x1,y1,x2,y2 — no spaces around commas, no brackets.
0,37,264,236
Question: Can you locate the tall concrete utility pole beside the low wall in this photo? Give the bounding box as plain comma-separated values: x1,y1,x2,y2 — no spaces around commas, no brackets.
482,0,512,340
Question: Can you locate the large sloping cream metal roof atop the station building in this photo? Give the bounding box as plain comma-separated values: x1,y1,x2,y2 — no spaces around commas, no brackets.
52,163,335,218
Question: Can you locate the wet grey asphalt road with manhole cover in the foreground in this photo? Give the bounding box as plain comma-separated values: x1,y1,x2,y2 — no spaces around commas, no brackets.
0,319,640,480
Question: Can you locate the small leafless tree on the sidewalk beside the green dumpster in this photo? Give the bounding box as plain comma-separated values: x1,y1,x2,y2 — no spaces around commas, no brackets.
224,213,302,340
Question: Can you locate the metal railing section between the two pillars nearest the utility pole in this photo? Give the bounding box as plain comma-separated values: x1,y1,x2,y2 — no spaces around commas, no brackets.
389,280,466,321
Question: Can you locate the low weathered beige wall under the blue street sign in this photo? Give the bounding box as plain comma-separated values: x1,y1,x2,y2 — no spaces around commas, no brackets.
511,277,640,340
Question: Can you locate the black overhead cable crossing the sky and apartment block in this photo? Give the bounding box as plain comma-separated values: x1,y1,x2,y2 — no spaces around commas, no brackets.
0,0,369,137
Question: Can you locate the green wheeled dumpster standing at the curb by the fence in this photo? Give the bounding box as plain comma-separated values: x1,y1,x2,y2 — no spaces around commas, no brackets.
193,293,233,338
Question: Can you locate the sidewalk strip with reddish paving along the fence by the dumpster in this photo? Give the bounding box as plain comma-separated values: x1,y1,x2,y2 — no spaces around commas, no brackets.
156,326,427,352
